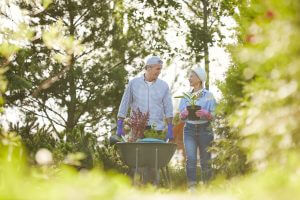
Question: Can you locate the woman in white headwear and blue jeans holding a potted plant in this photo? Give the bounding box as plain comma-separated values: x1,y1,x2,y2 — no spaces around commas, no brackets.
179,67,216,188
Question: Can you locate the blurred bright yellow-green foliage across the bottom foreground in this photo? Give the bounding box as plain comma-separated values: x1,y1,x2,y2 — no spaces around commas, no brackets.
0,121,300,200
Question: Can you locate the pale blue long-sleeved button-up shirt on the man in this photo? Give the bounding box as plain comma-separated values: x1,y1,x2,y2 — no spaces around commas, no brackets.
118,75,173,130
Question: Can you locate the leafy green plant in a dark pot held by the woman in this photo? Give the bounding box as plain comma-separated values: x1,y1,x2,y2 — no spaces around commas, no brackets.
175,92,201,121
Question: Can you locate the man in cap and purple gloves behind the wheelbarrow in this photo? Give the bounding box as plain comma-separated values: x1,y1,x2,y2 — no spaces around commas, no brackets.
117,56,173,185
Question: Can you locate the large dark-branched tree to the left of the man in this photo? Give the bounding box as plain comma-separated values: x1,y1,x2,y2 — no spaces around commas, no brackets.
6,0,177,134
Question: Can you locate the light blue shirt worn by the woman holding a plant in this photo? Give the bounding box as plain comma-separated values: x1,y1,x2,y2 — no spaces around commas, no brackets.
179,89,216,124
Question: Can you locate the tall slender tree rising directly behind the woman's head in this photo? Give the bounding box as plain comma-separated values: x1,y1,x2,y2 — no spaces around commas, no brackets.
181,0,238,89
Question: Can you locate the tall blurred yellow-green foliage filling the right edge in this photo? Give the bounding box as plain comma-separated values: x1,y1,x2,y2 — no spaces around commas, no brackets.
216,0,300,171
